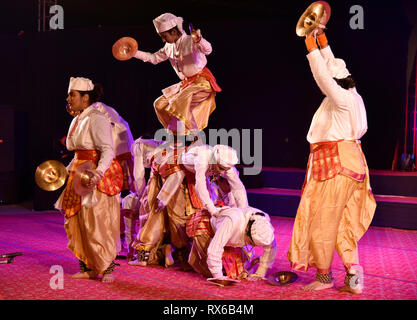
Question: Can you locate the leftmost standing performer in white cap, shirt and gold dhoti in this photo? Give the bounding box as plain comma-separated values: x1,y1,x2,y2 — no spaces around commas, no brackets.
55,78,123,282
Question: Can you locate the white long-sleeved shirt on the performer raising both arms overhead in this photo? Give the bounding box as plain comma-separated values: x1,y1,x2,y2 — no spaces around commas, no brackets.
307,46,368,143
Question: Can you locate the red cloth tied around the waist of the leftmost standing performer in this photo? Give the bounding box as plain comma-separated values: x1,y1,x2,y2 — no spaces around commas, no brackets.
62,150,123,218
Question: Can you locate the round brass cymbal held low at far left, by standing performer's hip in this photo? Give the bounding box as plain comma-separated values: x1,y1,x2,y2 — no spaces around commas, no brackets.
35,160,68,191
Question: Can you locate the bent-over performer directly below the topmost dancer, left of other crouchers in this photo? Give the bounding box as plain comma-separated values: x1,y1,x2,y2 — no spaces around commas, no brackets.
129,139,191,267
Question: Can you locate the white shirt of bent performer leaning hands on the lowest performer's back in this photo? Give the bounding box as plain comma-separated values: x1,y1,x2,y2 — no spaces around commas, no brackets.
181,145,248,214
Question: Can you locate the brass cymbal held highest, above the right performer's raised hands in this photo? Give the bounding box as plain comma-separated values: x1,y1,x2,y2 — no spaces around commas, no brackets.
295,1,331,37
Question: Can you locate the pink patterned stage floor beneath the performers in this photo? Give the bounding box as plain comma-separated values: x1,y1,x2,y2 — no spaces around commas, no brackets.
0,206,417,300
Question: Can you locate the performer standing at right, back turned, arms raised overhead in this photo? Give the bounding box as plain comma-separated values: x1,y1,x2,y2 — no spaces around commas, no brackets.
288,25,376,294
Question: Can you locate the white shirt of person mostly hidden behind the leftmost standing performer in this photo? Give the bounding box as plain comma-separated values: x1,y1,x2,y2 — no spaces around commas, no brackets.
92,102,133,156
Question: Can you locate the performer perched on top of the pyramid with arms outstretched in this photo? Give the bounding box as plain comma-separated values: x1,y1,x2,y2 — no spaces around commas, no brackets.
135,13,221,136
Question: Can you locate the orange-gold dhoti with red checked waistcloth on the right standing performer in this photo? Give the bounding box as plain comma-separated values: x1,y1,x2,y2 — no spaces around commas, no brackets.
288,140,376,273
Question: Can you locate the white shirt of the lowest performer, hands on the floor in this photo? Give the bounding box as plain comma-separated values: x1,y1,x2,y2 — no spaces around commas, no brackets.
207,207,277,278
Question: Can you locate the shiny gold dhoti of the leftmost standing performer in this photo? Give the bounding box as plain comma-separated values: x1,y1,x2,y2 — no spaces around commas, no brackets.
65,192,120,274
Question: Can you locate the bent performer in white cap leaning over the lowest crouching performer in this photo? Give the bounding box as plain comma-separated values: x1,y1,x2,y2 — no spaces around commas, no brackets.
181,145,248,279
